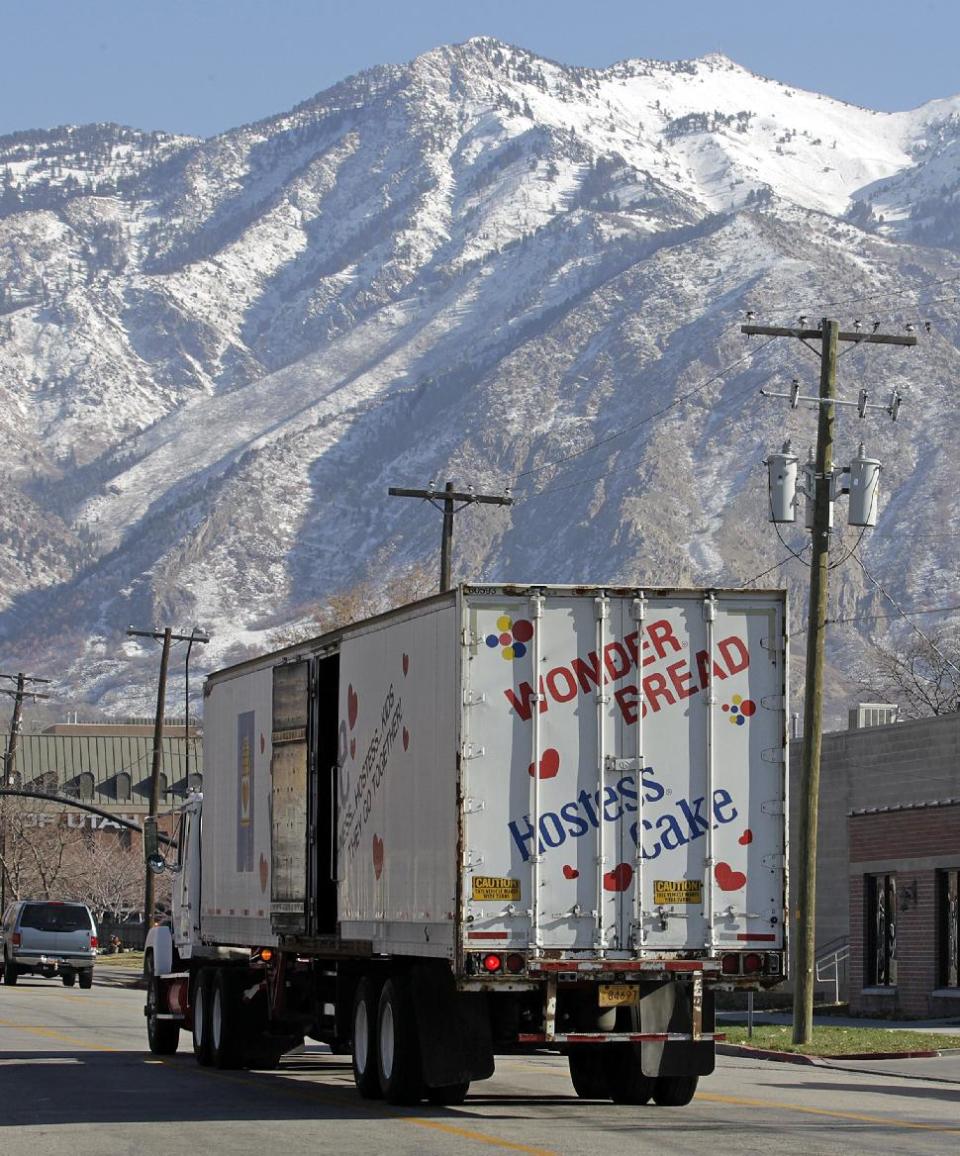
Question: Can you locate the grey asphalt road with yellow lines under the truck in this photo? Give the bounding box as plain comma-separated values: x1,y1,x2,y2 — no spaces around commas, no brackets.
0,969,960,1156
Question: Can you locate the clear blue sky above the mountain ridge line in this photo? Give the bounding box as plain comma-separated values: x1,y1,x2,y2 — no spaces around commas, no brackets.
7,0,960,136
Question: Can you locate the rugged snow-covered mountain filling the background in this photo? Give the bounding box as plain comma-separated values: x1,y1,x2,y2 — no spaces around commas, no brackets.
0,39,960,712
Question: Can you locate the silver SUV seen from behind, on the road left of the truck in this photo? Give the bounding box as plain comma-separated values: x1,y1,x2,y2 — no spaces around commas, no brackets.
0,899,97,987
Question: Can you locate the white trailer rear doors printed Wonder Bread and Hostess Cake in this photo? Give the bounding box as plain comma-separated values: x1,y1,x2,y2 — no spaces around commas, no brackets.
461,591,785,957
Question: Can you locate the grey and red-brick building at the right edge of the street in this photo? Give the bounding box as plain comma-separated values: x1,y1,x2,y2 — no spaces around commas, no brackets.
790,713,960,1016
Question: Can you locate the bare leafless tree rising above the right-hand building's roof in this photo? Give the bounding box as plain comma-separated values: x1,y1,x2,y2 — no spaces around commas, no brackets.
856,630,960,719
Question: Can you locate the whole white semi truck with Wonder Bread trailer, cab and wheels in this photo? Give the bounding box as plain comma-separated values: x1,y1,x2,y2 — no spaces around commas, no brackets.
146,586,788,1104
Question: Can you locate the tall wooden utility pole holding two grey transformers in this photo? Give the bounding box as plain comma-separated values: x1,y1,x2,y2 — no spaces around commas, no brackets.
740,317,917,1044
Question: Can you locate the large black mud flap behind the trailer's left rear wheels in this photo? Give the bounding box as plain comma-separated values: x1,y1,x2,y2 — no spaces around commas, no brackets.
411,965,494,1088
